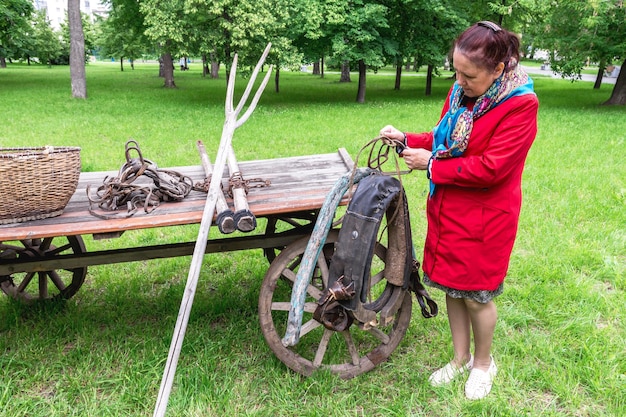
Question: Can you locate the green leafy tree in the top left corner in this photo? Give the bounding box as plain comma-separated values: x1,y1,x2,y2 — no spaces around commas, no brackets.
0,0,34,68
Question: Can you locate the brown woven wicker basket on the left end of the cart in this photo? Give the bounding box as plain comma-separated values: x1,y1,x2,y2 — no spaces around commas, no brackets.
0,146,80,224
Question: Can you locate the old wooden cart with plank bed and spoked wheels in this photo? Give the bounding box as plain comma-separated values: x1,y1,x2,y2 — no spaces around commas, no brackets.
0,149,411,378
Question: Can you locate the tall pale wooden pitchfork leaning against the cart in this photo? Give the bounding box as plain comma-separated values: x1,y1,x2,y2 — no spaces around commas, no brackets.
153,43,273,417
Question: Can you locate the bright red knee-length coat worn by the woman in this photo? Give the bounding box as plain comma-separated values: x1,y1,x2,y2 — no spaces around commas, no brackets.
407,88,539,291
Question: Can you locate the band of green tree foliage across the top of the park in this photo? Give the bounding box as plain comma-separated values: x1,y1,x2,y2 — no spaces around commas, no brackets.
0,0,626,102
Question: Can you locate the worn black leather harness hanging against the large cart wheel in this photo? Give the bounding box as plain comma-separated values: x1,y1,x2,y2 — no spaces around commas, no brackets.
314,172,438,331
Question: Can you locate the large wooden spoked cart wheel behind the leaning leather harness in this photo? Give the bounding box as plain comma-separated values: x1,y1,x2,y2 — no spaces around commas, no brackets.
259,230,412,379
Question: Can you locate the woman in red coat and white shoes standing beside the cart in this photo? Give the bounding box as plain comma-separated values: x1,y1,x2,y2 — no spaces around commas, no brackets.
380,21,539,399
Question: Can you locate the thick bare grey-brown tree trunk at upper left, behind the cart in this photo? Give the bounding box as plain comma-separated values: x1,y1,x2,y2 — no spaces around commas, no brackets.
67,0,87,98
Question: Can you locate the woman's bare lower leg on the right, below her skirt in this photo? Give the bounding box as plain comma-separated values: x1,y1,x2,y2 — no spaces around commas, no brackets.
463,299,498,371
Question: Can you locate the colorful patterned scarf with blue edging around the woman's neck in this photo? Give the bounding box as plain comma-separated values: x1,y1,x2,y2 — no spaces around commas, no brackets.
430,62,534,196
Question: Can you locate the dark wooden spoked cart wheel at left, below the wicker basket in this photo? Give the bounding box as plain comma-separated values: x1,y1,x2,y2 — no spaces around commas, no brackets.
0,236,87,302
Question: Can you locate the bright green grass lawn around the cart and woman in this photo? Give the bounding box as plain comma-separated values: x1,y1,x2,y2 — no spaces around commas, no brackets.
0,63,626,417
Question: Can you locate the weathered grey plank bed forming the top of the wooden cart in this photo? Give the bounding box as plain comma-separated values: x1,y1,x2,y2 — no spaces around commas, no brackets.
0,149,353,242
